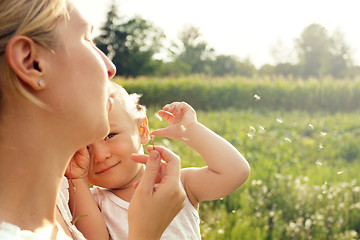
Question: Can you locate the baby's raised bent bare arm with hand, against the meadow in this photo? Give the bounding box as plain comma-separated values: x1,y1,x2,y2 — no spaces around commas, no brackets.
153,102,250,206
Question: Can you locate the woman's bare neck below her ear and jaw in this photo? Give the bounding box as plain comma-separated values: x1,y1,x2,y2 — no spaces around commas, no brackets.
0,107,71,231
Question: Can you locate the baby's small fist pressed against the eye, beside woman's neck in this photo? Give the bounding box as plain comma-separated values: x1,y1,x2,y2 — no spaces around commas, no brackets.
65,147,90,179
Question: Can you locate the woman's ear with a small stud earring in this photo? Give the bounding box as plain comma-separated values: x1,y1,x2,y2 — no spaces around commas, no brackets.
6,36,45,90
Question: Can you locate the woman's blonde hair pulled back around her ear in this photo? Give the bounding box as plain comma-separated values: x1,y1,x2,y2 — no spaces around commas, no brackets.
0,0,69,108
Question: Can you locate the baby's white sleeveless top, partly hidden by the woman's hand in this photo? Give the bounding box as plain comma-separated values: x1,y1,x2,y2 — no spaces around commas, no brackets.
91,187,201,240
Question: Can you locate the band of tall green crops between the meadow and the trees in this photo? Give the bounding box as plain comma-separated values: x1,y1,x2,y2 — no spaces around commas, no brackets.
115,76,360,113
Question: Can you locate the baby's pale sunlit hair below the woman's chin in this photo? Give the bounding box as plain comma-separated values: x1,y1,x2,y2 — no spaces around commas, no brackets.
111,82,146,120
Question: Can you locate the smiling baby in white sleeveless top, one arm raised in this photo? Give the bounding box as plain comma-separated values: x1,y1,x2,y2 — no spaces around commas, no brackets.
66,84,250,239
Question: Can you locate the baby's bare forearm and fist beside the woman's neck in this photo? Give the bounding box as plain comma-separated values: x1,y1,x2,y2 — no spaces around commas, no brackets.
65,148,109,240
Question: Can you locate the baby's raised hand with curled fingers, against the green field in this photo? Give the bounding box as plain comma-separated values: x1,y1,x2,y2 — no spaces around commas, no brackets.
152,102,197,139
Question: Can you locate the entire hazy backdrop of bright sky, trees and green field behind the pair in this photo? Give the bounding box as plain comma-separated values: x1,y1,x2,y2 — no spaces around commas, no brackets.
75,0,360,240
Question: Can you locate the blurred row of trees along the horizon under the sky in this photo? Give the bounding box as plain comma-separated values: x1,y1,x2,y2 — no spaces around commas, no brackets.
94,5,359,79
